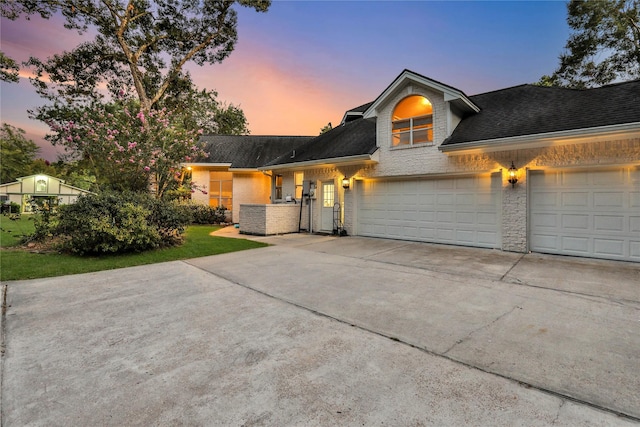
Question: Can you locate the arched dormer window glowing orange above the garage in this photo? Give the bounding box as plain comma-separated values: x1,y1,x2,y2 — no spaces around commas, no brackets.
391,95,433,147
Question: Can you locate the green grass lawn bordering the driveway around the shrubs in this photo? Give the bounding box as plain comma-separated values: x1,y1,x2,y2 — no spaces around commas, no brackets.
0,215,267,281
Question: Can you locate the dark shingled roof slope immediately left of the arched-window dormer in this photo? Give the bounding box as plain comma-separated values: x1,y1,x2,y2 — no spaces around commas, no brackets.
265,119,377,166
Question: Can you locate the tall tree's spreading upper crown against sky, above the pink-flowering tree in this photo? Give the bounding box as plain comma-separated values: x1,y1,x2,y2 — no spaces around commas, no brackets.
0,0,270,113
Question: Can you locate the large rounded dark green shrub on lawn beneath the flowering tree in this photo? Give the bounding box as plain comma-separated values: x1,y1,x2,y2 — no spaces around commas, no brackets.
55,193,188,254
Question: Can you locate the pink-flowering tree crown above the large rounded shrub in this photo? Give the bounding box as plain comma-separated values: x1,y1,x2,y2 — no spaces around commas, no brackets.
47,103,206,198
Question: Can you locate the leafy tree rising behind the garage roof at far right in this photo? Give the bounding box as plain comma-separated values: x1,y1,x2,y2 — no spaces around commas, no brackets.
538,0,640,88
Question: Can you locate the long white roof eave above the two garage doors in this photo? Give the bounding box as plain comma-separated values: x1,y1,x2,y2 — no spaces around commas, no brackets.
438,122,640,154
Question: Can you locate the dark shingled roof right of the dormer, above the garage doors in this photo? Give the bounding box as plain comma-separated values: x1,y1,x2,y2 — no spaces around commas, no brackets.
442,80,640,146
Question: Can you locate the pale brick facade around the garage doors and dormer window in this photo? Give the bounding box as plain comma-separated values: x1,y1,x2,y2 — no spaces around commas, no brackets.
283,85,640,252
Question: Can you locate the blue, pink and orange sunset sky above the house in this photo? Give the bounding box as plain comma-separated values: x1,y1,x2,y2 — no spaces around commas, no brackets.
0,1,569,160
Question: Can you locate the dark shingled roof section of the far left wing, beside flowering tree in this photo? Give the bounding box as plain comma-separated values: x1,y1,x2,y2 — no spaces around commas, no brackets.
200,135,313,169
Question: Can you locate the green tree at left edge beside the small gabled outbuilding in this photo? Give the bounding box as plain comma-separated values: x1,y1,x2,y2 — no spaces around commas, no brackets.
0,123,39,183
